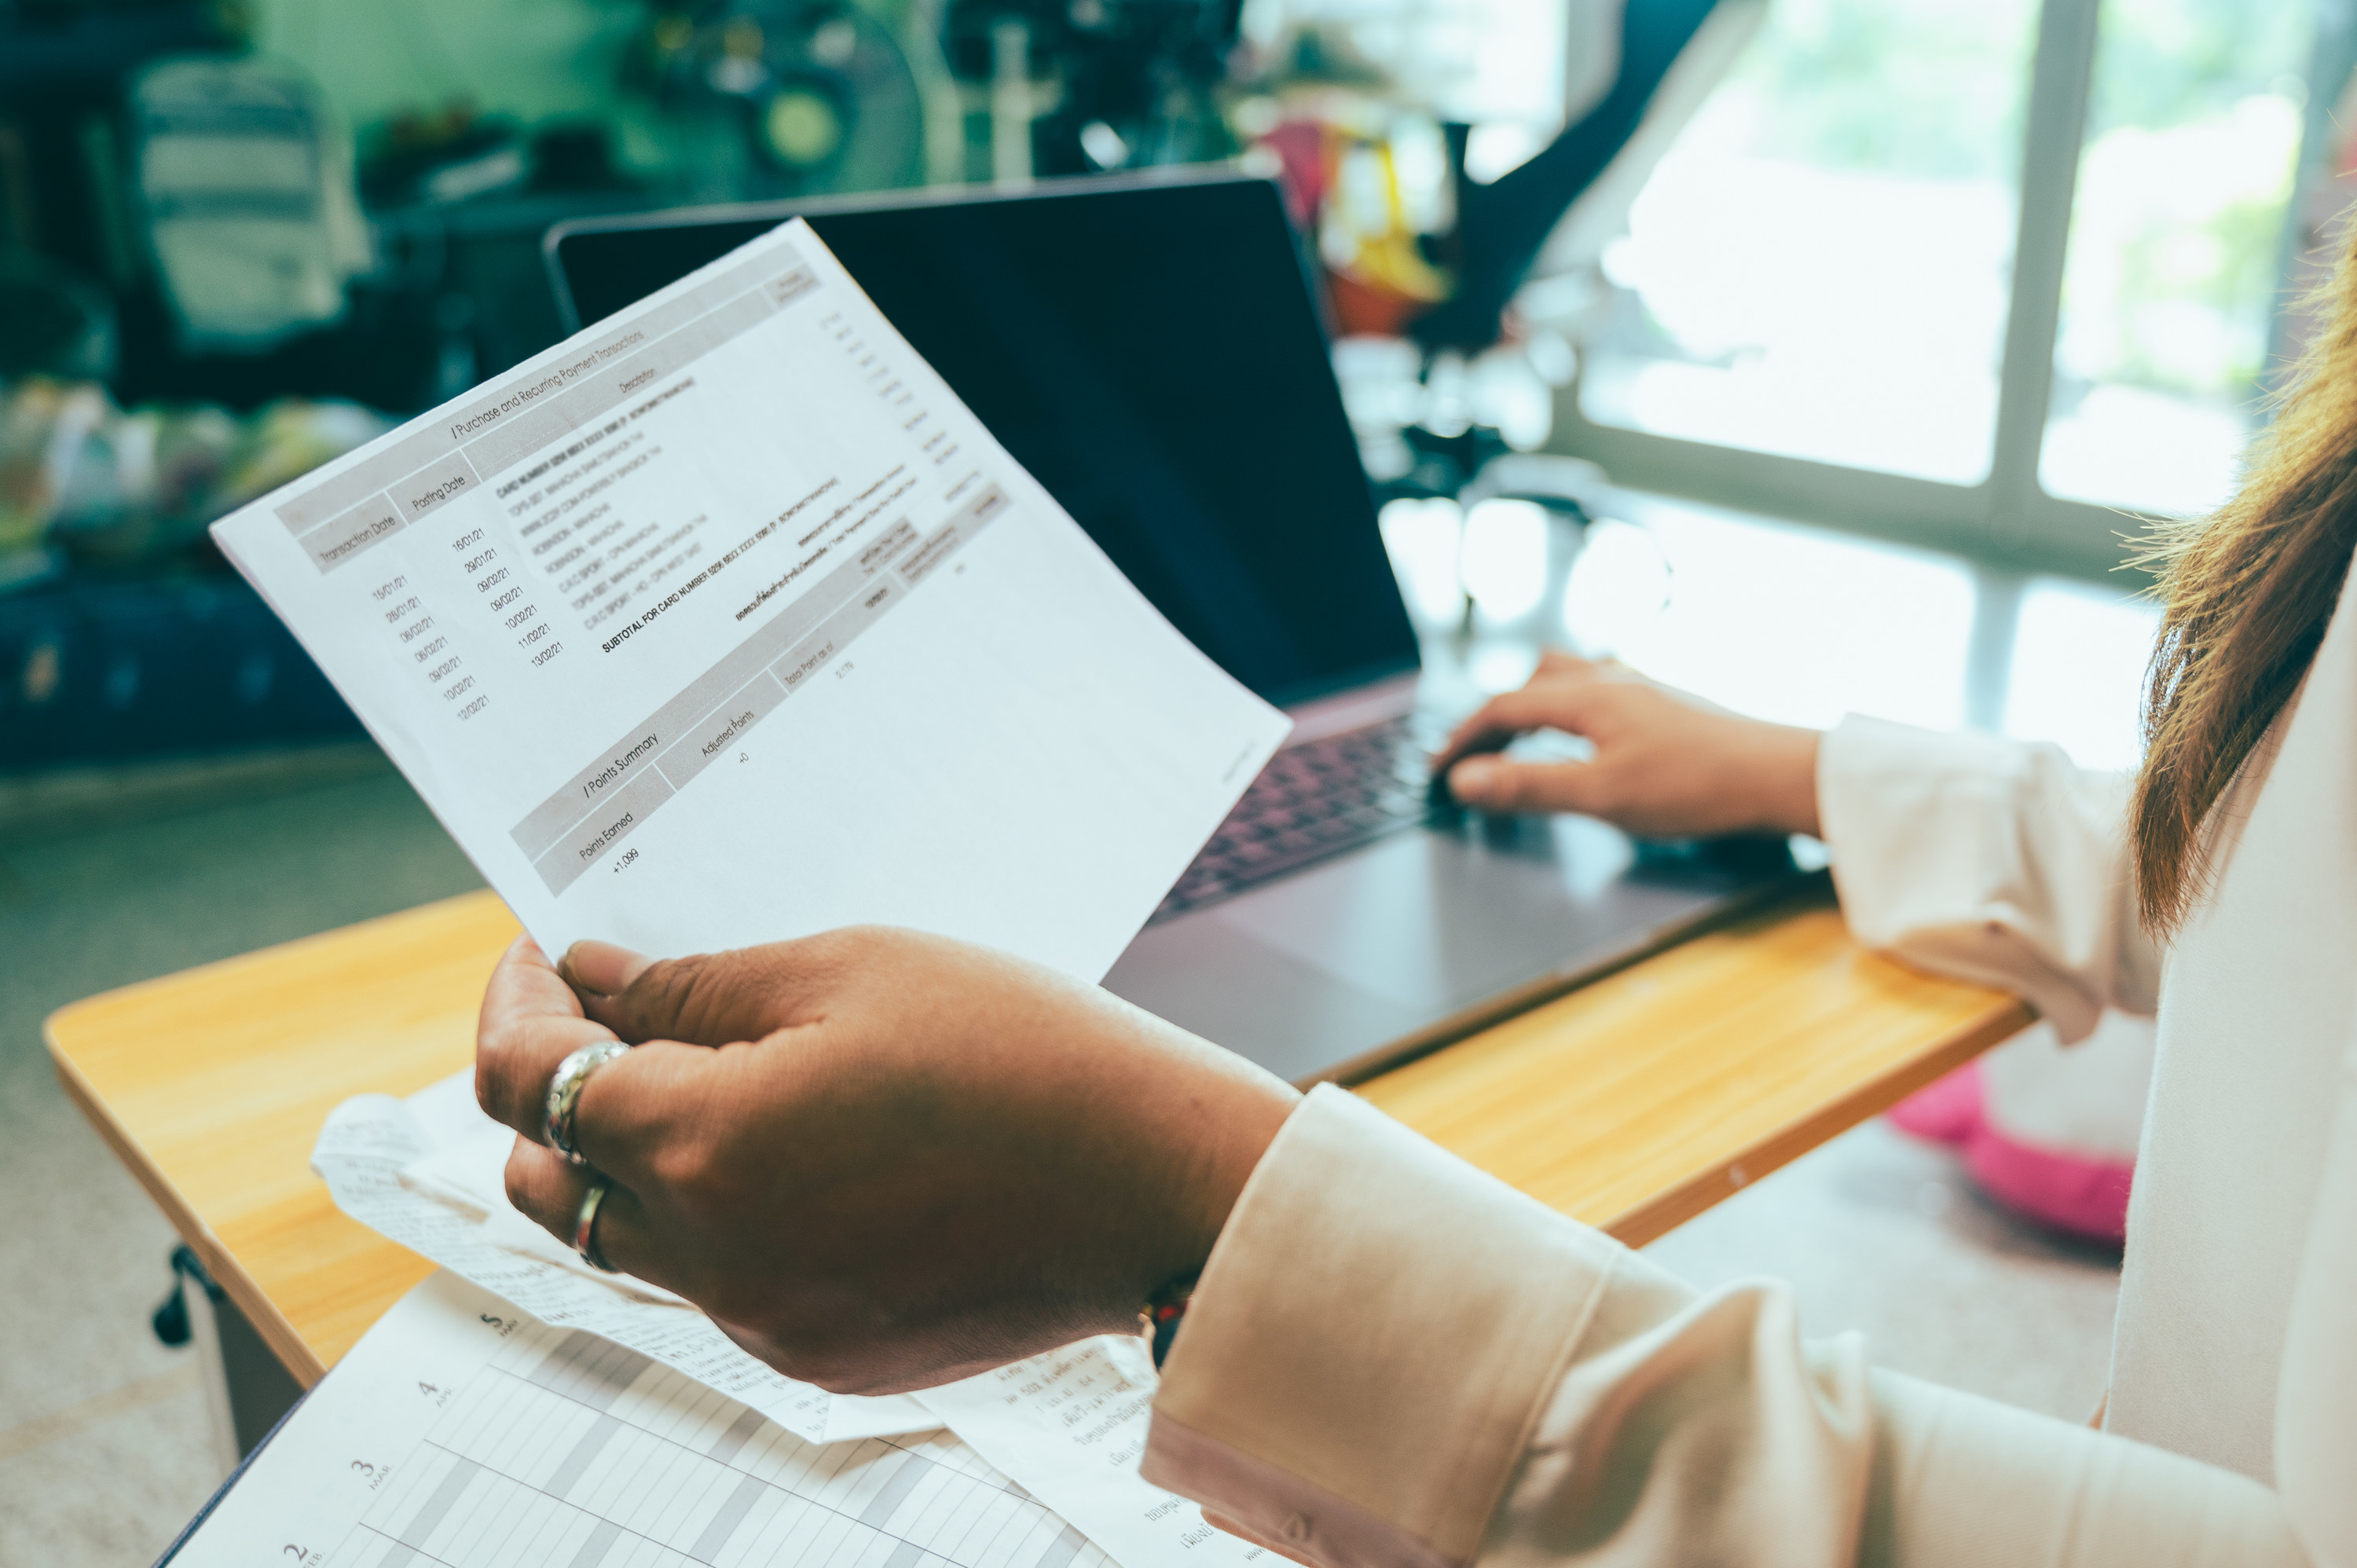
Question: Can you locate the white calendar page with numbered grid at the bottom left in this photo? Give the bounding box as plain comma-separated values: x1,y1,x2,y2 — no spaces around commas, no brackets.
172,1273,1131,1568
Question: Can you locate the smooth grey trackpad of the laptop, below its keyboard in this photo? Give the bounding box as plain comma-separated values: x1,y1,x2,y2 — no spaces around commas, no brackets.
1214,819,1699,1012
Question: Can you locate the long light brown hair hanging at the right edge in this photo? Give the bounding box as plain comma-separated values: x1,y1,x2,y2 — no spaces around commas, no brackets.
2131,224,2357,934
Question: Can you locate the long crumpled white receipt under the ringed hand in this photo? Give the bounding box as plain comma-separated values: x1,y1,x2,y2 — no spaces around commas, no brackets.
311,1075,940,1443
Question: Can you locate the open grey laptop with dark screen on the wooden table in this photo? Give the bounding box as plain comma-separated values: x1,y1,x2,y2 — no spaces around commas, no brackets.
547,174,1791,1085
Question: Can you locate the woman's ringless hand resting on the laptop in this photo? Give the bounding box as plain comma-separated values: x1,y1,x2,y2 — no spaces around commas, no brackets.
1433,653,1820,837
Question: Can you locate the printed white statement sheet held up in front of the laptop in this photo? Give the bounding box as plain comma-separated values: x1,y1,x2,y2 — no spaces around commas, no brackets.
214,219,1287,981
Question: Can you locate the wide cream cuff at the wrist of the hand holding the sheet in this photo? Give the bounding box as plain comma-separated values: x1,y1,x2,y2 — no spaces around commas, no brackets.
1143,1085,1631,1568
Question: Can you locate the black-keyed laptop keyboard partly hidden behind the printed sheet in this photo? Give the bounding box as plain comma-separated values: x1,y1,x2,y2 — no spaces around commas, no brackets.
1146,714,1440,925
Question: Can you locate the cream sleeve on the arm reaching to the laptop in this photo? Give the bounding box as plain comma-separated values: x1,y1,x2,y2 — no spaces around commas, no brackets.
1817,716,2161,1042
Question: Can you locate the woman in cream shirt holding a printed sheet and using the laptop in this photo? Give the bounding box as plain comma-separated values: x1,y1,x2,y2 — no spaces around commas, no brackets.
478,238,2357,1568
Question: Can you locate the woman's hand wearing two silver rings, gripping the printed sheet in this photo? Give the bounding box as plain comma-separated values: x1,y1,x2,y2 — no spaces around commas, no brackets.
476,927,1299,1394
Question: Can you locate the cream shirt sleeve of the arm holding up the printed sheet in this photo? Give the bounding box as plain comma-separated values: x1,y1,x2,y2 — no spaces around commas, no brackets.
1146,1087,2310,1568
